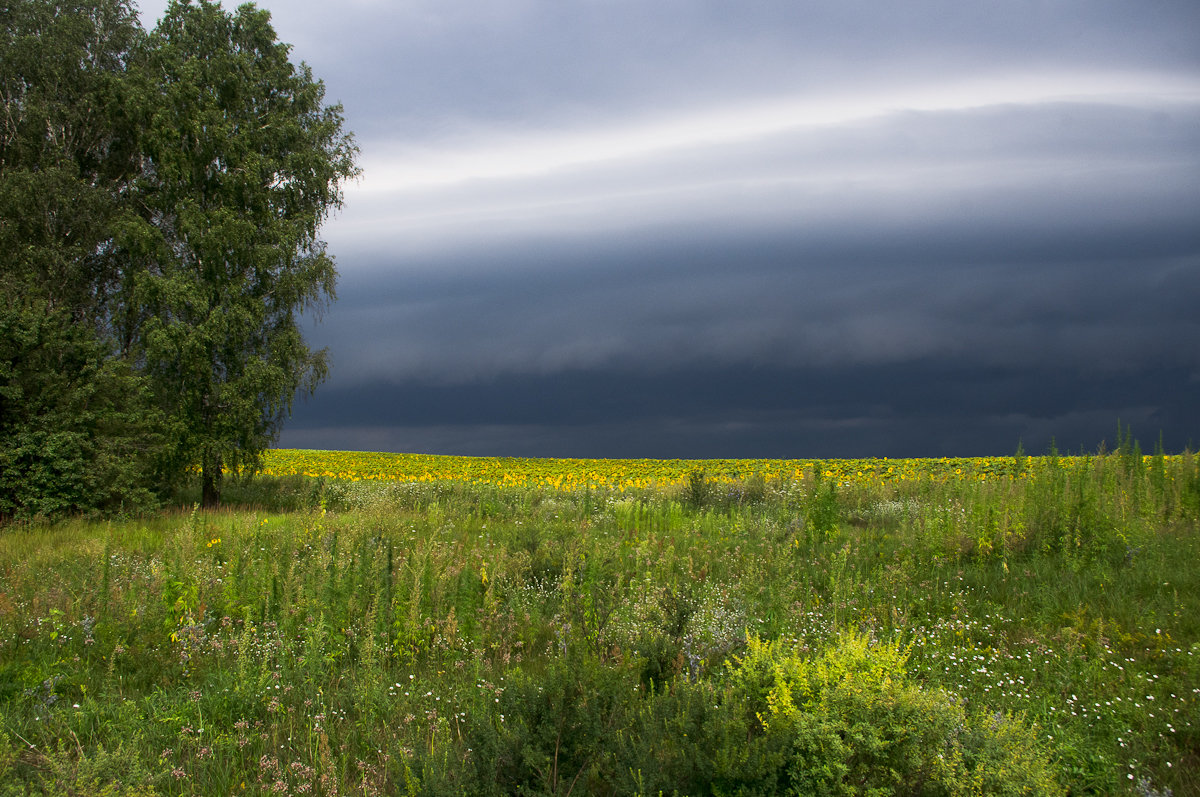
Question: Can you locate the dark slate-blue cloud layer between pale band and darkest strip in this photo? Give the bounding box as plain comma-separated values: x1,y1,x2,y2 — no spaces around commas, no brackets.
319,147,1200,382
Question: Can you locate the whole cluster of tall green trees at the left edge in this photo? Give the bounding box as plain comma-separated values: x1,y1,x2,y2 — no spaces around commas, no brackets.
0,0,356,517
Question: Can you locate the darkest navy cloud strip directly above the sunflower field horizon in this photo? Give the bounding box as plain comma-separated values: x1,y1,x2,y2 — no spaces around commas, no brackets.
288,362,1196,459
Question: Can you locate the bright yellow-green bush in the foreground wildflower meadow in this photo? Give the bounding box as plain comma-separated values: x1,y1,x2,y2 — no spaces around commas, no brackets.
733,634,1062,795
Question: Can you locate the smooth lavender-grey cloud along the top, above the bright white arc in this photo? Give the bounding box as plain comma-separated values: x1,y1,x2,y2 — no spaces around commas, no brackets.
312,0,1200,138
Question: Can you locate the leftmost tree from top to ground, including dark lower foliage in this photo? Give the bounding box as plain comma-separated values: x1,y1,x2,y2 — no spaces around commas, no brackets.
0,0,160,520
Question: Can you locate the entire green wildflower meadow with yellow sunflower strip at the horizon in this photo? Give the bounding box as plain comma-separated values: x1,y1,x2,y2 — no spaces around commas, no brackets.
0,447,1200,796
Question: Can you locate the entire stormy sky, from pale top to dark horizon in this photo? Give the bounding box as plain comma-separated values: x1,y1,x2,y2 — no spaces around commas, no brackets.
140,0,1200,457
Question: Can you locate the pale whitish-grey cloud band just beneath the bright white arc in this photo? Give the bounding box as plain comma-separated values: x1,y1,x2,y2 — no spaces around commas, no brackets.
329,103,1200,261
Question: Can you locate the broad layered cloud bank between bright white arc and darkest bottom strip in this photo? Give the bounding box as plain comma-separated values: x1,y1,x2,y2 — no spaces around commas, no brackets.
323,94,1200,398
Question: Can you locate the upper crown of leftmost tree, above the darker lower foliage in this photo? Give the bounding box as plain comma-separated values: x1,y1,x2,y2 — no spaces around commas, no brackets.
0,0,144,316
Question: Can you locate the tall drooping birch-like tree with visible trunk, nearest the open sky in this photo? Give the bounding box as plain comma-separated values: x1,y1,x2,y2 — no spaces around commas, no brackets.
120,0,358,504
